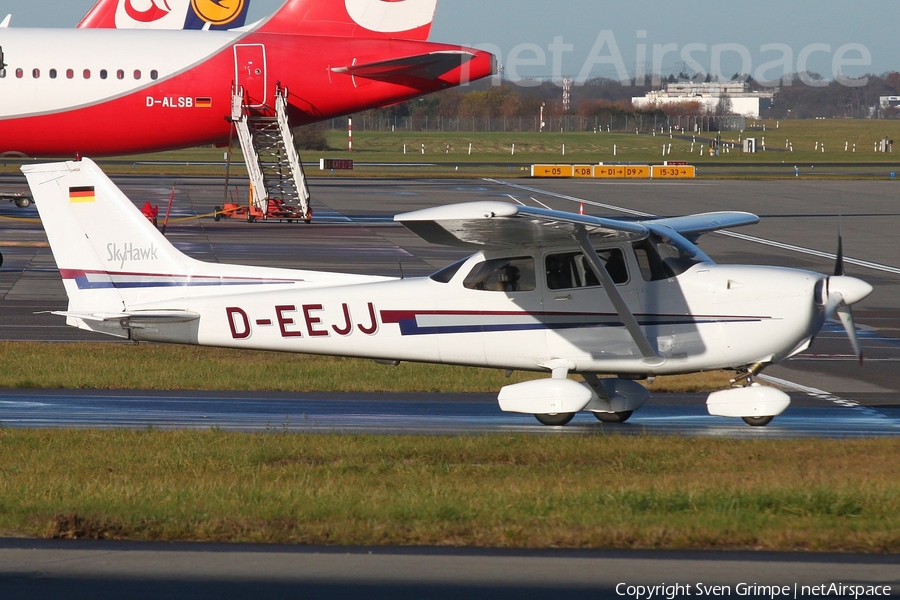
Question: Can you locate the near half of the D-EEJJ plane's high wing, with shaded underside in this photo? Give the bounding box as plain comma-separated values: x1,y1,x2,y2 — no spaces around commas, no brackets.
394,202,649,248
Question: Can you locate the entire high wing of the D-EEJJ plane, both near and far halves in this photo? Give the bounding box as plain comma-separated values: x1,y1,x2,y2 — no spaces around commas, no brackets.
394,202,759,248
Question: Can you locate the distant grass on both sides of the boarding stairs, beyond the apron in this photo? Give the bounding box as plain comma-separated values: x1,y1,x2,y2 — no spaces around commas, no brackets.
0,119,900,178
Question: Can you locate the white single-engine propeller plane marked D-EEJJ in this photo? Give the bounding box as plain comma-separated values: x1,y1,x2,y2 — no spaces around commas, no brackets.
22,159,872,425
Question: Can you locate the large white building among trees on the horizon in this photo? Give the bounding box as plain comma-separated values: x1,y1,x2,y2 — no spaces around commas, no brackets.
631,81,775,119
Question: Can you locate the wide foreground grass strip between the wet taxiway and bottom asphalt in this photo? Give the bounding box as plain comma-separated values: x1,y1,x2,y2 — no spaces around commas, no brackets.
0,429,900,552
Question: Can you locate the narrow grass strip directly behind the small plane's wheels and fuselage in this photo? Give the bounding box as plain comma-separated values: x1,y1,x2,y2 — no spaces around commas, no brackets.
0,342,731,393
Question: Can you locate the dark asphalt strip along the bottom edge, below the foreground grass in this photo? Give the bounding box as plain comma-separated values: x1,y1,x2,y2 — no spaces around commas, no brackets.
0,540,900,600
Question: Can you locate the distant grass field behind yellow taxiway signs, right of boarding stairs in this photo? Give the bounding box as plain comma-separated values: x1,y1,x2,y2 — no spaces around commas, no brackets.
318,119,900,166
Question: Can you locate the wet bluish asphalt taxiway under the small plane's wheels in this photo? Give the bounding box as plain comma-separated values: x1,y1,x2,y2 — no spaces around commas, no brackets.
0,390,900,439
